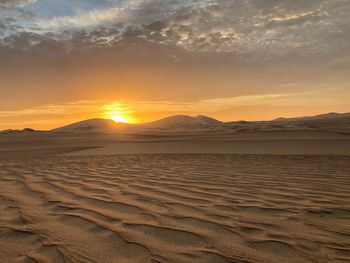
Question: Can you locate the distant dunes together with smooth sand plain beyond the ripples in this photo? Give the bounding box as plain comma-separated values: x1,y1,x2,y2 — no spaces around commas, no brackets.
0,113,350,156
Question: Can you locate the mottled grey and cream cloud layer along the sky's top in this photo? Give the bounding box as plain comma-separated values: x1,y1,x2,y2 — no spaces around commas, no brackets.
0,0,350,55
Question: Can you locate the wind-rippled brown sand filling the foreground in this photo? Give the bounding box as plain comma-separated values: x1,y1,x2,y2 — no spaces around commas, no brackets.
0,154,350,263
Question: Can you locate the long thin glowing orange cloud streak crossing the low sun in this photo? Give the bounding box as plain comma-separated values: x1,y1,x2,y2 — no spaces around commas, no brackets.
0,93,305,118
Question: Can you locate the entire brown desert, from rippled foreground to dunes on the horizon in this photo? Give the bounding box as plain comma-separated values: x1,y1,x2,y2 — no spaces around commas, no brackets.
0,115,350,263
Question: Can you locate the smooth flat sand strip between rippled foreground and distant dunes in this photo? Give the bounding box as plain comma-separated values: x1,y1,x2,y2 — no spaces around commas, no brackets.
0,130,350,158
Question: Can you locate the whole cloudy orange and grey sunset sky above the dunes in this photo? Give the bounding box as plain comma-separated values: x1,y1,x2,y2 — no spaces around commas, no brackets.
0,0,350,129
